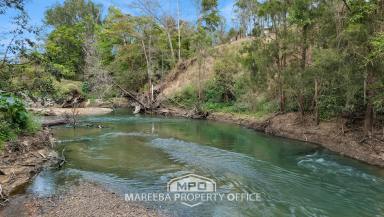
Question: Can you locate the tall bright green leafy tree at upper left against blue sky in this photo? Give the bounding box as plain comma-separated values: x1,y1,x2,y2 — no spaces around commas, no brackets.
45,0,101,80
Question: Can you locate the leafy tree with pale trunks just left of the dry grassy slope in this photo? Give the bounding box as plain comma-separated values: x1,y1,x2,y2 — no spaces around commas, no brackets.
99,8,172,100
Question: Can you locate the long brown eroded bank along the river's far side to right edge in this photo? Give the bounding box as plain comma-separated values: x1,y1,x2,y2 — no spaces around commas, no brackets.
156,108,384,167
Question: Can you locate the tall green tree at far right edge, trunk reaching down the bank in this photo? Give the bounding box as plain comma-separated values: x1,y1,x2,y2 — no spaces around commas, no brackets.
341,0,384,136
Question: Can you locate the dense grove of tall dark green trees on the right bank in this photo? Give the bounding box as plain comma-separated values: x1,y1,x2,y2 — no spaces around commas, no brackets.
237,0,384,133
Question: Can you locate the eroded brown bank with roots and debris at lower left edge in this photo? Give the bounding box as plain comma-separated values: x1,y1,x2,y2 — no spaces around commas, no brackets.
0,129,58,206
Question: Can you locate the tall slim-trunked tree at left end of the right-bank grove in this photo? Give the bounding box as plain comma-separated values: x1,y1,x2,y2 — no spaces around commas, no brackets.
236,0,295,112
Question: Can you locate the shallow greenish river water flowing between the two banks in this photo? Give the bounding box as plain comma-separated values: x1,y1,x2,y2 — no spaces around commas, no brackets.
28,113,384,217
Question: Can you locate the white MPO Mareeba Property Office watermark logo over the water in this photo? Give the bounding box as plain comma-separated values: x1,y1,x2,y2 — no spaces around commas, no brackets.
125,174,261,207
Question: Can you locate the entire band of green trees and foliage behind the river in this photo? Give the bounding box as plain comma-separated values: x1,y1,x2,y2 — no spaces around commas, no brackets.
0,0,384,139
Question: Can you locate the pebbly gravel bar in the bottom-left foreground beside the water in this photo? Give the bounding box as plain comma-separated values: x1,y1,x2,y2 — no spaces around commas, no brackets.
0,182,165,217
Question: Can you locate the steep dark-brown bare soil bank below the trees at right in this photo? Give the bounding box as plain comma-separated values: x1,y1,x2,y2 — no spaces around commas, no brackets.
265,113,384,167
